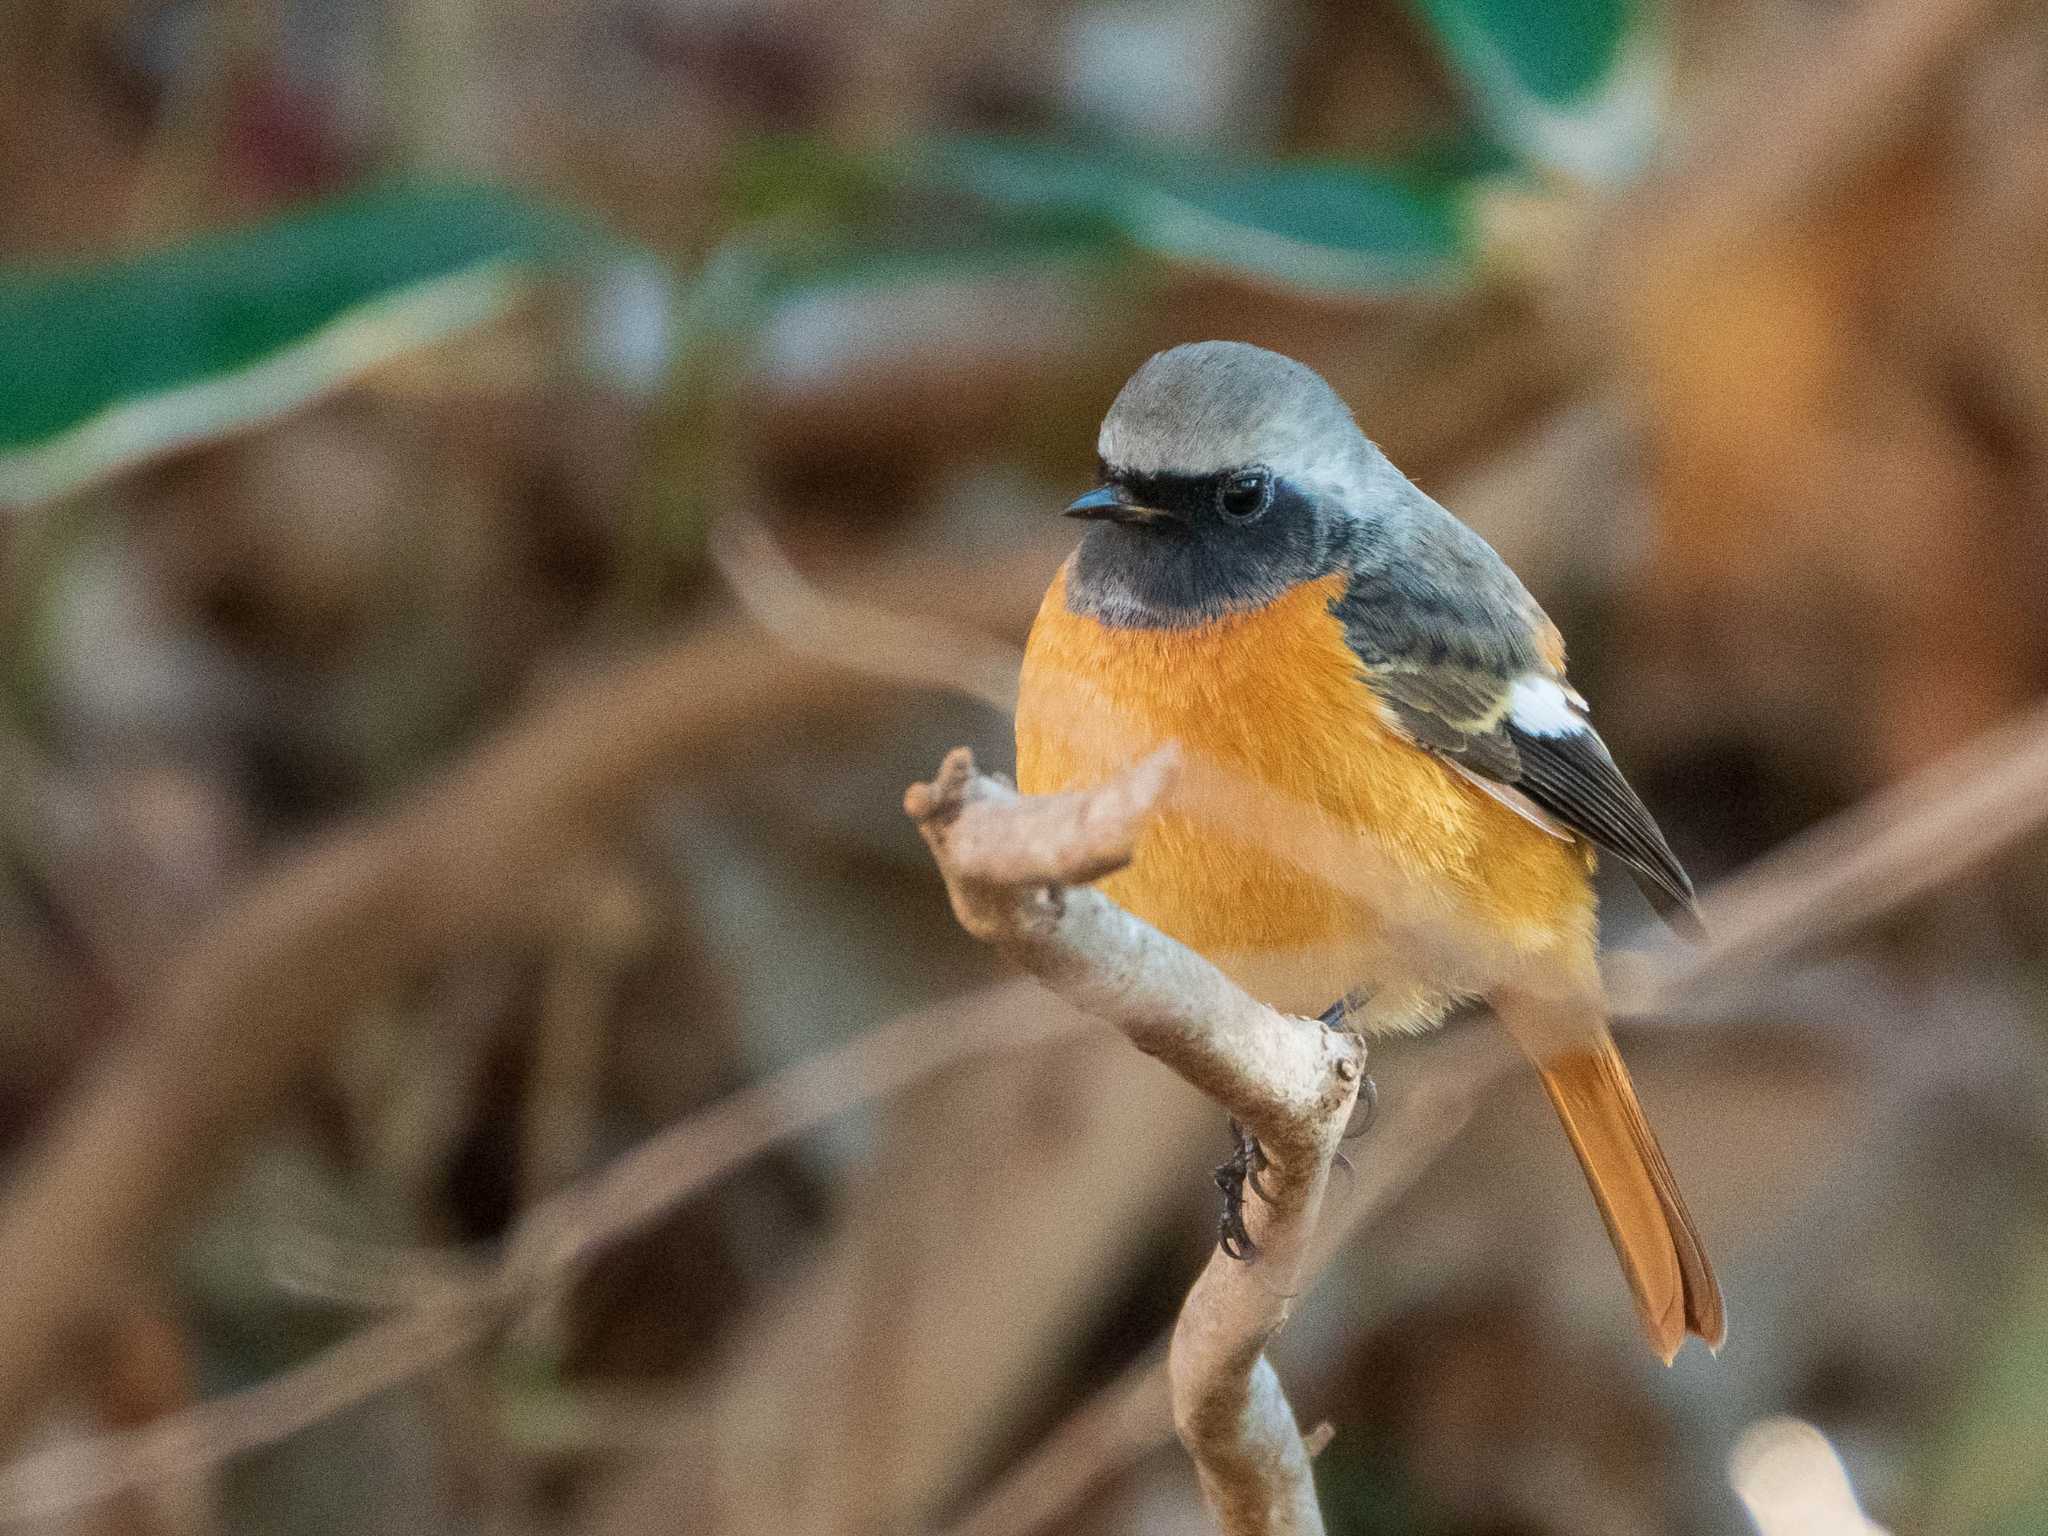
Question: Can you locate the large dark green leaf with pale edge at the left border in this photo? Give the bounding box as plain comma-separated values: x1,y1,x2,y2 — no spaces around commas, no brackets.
0,184,625,506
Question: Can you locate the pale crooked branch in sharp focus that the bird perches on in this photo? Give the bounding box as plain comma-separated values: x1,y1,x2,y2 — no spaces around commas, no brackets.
903,748,1366,1536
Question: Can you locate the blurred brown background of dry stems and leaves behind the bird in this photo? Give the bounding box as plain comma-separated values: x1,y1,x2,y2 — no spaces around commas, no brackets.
0,0,2048,1536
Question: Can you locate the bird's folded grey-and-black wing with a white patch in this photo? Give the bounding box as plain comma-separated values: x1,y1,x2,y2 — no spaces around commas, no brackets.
1333,552,1700,938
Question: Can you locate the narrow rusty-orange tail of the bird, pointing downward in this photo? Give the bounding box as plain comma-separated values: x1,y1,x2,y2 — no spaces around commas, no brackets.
1538,1032,1729,1366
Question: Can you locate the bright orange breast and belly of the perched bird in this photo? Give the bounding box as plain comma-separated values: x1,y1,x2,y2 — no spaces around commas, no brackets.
1018,561,1593,1028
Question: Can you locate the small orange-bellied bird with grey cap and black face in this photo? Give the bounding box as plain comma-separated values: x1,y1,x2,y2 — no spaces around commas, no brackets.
1016,340,1726,1364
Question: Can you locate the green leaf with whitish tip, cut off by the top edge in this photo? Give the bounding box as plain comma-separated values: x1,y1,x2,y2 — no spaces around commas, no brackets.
1409,0,1669,182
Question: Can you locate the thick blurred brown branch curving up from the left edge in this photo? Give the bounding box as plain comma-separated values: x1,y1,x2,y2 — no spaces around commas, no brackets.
0,610,909,1446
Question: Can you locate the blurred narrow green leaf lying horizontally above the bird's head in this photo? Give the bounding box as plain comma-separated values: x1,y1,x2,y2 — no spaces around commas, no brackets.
905,139,1473,293
